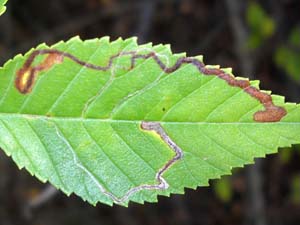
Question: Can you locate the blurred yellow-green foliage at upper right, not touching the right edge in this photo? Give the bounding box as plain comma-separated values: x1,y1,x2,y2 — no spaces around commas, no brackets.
247,1,276,49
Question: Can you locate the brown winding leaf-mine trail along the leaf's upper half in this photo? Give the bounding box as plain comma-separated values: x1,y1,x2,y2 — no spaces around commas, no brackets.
15,49,287,122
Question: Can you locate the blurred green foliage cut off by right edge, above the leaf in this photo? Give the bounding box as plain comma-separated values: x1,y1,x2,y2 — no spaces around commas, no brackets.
275,28,300,83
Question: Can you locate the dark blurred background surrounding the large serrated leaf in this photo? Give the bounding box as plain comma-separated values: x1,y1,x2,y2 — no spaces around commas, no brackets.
0,0,300,225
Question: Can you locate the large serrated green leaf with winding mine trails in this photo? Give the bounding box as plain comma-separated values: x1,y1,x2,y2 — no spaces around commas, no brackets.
0,37,300,205
